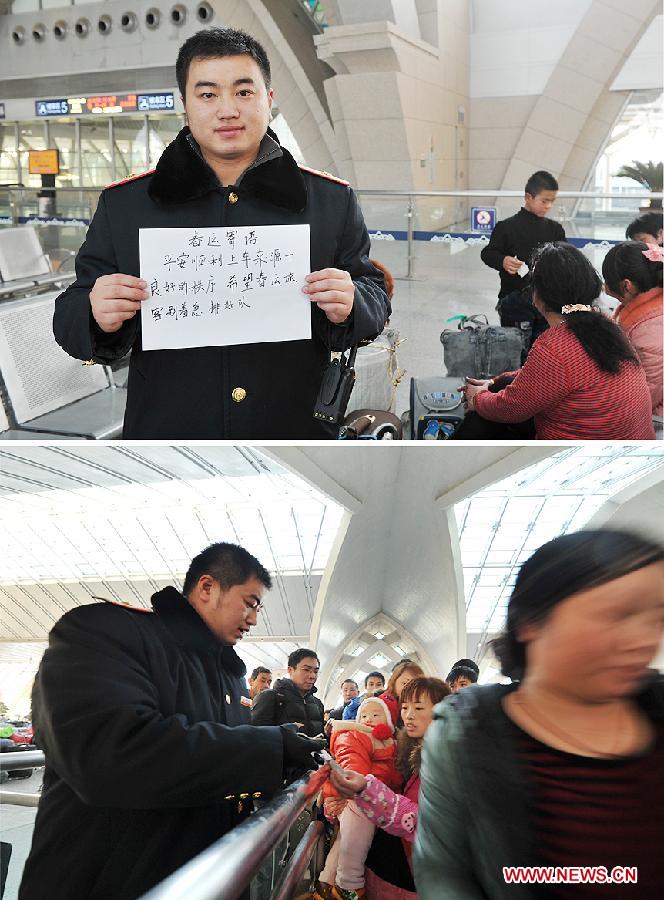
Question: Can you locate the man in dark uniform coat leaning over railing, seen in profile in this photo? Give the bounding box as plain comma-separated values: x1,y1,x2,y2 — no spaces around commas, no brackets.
19,544,324,900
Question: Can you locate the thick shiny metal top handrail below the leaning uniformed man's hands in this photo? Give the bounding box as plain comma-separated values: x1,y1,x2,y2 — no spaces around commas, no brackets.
142,766,330,900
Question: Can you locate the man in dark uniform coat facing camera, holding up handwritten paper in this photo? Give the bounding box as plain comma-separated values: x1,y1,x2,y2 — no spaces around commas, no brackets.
53,29,390,440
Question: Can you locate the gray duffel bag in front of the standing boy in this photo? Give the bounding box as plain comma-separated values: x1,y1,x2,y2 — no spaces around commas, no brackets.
440,316,523,378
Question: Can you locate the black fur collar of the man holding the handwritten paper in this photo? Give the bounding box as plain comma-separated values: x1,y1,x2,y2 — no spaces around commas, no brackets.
148,126,307,212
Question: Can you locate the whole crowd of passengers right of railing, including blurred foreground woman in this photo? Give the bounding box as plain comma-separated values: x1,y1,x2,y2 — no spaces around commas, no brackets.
250,530,664,900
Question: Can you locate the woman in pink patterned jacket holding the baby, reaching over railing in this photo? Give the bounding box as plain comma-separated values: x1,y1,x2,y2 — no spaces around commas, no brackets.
331,678,450,900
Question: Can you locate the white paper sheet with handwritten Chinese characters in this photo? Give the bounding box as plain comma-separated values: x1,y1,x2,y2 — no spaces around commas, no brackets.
139,225,311,350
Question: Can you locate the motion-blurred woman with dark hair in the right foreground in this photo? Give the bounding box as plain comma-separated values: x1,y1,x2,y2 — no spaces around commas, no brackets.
413,530,664,900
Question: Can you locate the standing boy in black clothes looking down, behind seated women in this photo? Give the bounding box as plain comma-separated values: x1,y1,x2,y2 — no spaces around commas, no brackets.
481,171,566,343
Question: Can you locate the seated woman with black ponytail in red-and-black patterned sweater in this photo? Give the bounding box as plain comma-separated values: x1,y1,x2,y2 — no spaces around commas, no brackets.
455,242,655,440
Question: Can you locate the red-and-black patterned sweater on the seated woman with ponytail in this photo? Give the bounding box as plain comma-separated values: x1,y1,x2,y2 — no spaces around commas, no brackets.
475,322,655,440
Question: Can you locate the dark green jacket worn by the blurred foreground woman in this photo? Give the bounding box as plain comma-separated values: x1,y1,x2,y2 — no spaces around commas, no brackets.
413,677,664,900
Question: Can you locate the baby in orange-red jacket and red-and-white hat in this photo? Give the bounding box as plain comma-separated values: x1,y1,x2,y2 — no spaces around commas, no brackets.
318,694,403,900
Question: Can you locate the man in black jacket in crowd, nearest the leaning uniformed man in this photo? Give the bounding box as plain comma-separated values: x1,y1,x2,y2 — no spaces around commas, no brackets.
251,647,324,737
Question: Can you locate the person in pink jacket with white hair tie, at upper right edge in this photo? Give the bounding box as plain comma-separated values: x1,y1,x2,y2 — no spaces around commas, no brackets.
602,241,664,416
